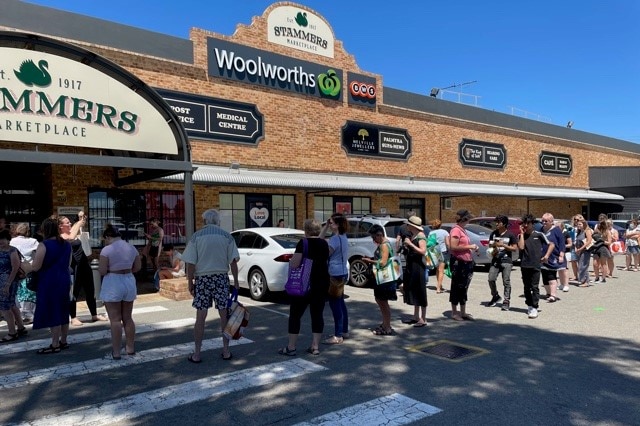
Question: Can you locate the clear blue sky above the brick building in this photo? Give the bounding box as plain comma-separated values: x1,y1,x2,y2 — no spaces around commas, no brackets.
29,0,640,143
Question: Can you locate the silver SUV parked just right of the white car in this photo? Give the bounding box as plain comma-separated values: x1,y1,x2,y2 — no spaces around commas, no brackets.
328,215,406,287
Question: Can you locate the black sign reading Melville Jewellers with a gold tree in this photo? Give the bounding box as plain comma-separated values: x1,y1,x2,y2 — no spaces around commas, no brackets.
342,121,411,160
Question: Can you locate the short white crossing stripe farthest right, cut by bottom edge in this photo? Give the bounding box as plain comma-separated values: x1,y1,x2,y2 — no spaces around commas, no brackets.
295,393,442,426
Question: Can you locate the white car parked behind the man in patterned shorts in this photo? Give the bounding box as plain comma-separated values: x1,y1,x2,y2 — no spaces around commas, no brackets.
229,227,304,300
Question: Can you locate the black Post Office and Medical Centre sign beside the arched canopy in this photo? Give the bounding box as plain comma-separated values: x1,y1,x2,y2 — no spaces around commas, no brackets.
156,89,264,144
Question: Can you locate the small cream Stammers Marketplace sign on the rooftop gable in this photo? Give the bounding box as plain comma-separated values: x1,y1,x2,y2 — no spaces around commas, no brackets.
267,6,334,58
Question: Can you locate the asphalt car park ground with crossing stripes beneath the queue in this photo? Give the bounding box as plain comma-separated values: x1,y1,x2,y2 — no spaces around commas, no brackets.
0,258,640,426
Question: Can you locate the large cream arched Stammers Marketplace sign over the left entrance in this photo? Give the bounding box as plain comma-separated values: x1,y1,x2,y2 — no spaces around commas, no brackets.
0,47,178,154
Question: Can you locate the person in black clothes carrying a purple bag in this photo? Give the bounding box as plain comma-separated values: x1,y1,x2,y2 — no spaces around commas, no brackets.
278,219,329,356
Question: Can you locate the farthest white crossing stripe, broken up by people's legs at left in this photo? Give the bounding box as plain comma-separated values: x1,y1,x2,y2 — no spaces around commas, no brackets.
0,318,196,355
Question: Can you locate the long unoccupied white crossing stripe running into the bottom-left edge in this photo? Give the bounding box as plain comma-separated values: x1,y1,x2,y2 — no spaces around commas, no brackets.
20,358,326,426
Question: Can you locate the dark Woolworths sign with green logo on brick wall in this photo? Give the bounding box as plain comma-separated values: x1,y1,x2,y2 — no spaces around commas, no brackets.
207,38,343,101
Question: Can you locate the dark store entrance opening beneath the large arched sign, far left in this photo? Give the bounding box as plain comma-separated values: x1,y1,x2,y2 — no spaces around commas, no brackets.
0,162,51,235
